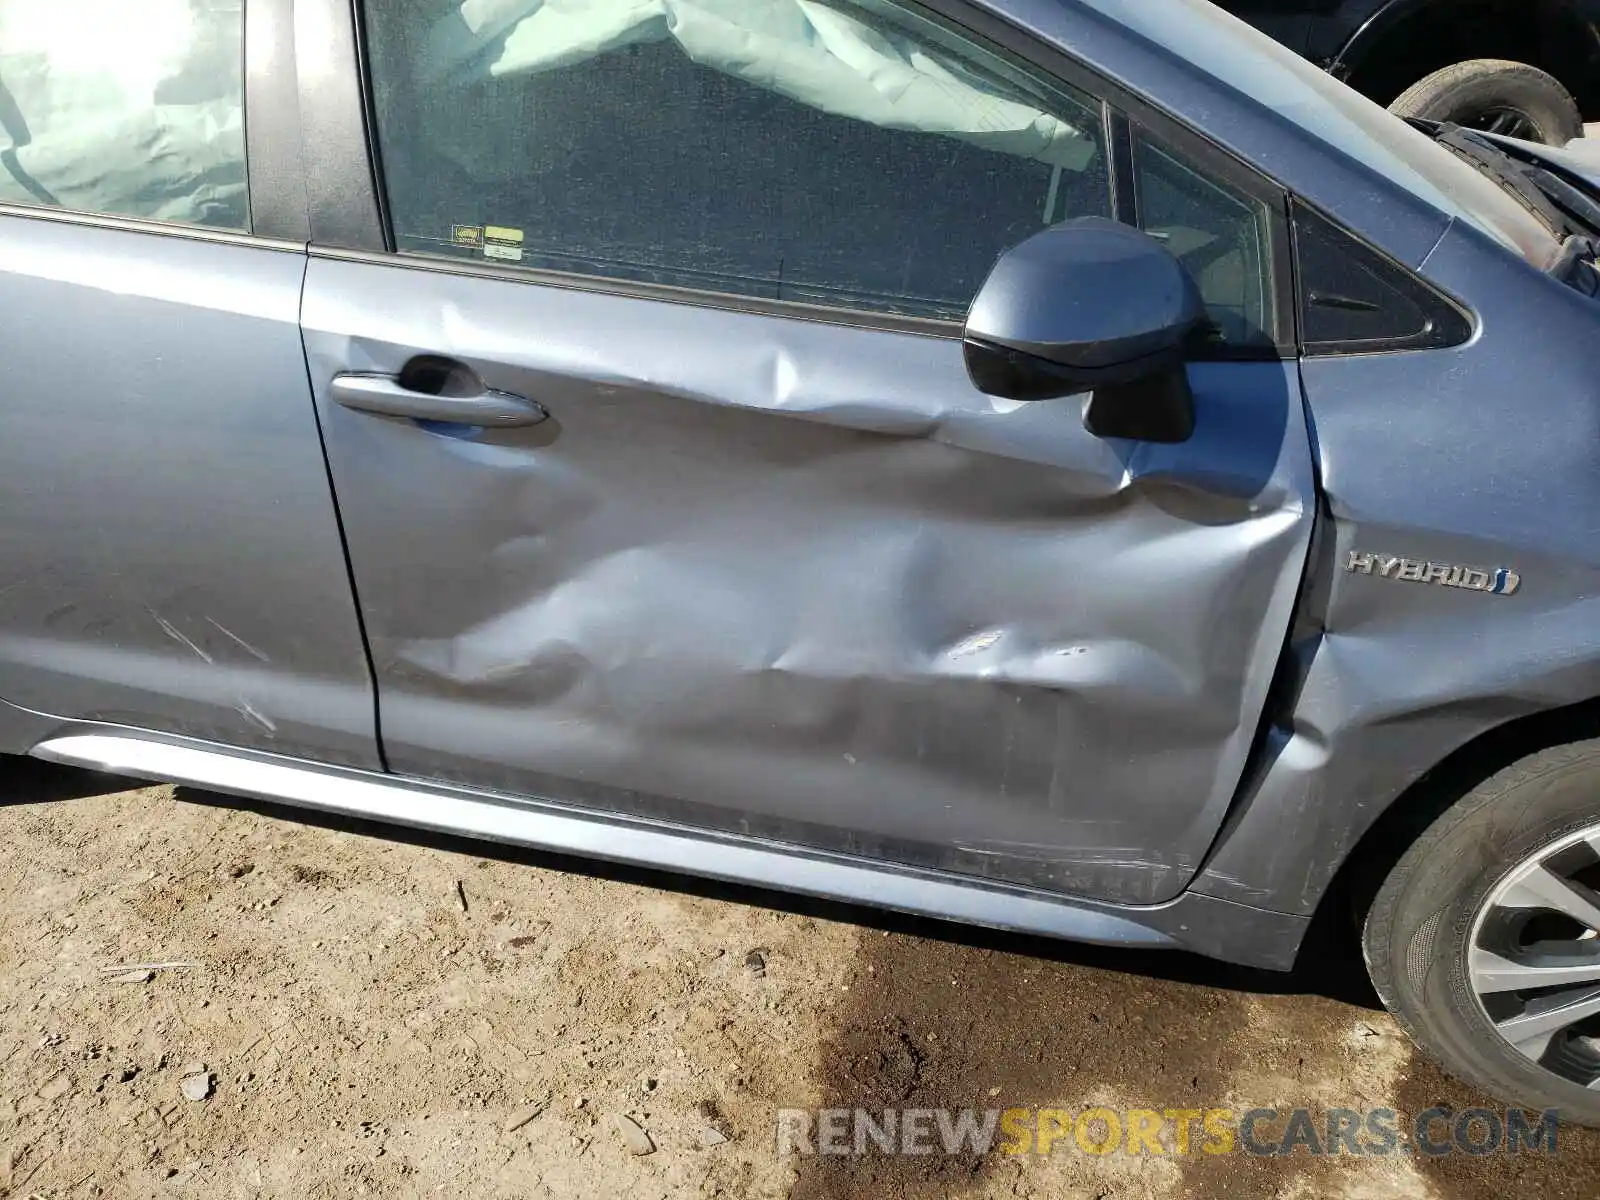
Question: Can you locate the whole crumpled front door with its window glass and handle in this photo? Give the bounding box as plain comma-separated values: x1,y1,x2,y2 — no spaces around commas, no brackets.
302,0,1314,902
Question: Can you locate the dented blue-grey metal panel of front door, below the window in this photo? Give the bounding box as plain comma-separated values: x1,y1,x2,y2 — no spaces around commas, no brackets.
307,262,1310,901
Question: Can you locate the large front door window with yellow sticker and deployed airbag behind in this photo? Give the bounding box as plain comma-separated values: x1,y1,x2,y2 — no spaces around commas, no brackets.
365,0,1110,318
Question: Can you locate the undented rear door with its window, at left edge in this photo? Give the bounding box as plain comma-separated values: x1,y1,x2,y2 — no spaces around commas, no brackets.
0,0,378,766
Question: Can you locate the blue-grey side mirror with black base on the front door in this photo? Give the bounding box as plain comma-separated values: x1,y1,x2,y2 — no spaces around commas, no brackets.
965,216,1206,442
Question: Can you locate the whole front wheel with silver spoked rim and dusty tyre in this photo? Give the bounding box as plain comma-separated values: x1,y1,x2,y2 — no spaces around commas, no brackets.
1363,741,1600,1126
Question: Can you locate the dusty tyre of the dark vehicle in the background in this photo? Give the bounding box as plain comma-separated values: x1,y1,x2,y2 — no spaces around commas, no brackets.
1389,58,1584,146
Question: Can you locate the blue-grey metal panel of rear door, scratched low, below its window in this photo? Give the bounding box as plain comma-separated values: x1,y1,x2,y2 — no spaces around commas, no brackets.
0,219,379,766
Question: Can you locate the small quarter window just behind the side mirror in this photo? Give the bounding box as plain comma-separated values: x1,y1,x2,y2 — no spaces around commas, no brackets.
1134,133,1275,347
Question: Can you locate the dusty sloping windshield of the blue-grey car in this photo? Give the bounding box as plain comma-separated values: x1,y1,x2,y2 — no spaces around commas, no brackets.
1083,0,1555,266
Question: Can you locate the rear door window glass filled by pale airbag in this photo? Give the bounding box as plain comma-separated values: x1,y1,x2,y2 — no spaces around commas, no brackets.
0,0,250,229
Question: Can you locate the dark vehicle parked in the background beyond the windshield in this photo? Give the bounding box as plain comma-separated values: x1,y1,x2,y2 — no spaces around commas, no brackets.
1218,0,1600,146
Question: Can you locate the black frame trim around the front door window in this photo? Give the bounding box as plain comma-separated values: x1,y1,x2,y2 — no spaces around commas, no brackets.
312,0,1298,352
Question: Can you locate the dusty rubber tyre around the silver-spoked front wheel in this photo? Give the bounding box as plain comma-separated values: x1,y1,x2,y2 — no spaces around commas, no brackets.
1362,741,1600,1126
